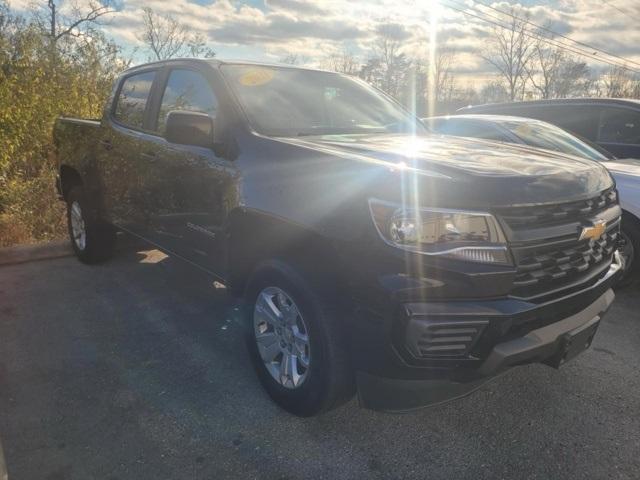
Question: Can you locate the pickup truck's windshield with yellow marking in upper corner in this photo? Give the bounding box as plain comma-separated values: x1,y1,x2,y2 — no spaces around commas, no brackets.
222,65,425,137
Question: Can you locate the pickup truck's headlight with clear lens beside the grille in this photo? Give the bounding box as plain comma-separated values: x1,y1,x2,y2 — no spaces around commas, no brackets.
369,199,511,265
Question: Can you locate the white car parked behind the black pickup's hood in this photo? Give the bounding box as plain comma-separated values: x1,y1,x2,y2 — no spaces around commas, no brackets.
422,114,640,283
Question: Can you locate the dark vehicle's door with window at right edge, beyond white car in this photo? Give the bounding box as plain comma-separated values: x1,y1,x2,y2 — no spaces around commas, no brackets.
597,106,640,158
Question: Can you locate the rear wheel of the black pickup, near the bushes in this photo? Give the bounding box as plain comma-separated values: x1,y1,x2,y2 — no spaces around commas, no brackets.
67,187,116,263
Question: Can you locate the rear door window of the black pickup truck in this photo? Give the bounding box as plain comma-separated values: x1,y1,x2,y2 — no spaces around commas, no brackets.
114,72,156,129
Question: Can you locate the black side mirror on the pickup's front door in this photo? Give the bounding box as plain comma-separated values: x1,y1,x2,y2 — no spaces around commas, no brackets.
164,110,213,148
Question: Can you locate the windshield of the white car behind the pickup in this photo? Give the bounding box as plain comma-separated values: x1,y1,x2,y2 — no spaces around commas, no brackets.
500,122,608,162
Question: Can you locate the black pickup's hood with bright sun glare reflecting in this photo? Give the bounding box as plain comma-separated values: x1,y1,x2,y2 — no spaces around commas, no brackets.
285,134,613,208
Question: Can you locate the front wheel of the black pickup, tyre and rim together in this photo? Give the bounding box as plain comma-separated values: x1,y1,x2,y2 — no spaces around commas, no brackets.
245,260,355,417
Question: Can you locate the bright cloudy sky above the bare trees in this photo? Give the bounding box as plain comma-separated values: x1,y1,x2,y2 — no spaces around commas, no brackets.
9,0,640,84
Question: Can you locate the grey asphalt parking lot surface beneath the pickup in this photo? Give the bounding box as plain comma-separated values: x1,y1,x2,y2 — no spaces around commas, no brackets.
0,247,640,480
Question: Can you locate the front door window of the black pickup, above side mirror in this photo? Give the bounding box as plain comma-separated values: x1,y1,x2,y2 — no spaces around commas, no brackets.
156,69,218,133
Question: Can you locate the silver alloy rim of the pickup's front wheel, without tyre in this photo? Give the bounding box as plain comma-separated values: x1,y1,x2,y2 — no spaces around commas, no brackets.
253,287,311,389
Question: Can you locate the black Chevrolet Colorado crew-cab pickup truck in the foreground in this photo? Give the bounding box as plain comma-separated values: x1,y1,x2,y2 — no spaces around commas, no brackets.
54,59,621,416
